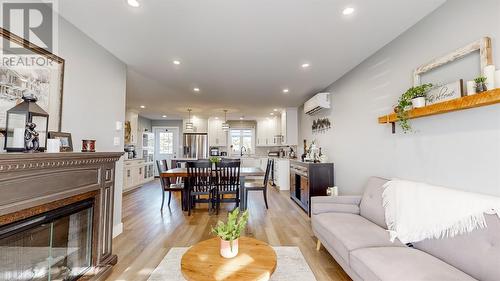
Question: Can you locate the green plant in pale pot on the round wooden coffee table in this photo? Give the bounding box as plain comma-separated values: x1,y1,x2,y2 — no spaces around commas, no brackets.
212,208,248,259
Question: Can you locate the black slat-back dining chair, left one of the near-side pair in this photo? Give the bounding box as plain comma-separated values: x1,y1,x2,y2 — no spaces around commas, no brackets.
186,161,214,216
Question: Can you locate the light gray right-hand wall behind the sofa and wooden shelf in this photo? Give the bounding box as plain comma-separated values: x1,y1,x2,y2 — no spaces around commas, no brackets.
299,0,500,195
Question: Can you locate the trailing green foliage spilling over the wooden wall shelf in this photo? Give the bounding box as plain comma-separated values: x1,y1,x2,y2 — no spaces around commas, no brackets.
395,83,434,134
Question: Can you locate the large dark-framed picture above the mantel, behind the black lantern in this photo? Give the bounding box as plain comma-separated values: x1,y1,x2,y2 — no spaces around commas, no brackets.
0,28,65,131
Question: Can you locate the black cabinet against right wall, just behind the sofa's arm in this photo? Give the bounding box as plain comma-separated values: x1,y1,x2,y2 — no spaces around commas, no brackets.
290,161,334,215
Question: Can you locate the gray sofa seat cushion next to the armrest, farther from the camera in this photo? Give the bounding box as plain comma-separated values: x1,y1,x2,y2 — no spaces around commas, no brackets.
311,213,406,263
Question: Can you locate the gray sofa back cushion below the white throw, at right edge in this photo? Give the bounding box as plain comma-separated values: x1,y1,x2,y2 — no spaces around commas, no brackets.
414,212,500,281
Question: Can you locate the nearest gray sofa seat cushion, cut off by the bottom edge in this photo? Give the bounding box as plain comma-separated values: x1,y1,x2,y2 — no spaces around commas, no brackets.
349,247,476,281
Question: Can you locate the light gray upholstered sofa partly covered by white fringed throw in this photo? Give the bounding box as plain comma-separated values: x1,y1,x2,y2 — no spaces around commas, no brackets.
311,177,500,281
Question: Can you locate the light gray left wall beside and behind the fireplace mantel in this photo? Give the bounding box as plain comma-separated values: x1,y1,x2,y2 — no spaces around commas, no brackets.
58,18,126,235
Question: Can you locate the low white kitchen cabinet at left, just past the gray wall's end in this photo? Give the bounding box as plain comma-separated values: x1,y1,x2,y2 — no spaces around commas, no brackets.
123,159,154,192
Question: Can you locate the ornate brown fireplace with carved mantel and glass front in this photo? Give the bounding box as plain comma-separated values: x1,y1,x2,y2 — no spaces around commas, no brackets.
0,152,123,281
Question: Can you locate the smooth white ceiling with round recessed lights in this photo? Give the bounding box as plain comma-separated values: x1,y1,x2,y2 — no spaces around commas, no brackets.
59,0,445,119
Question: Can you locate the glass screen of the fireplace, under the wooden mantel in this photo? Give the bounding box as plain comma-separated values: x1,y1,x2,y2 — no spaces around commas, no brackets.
0,201,93,281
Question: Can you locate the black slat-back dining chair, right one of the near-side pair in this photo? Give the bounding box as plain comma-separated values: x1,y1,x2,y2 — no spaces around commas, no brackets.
214,160,241,213
